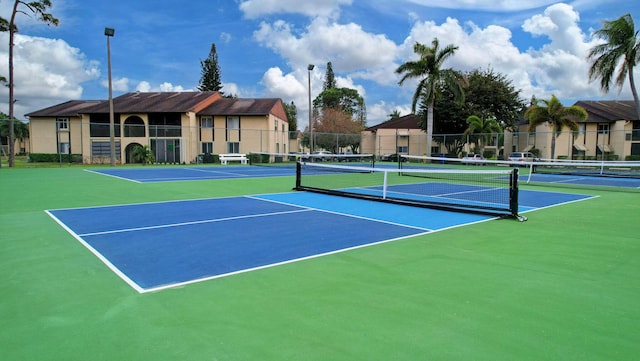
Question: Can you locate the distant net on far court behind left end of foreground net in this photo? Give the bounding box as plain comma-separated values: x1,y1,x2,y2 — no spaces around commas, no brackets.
249,152,375,168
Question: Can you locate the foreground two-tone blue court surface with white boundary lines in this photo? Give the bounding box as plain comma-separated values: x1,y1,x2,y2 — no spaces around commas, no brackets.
47,190,590,292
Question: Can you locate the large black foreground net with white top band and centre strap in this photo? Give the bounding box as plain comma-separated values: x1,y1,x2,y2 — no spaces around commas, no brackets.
295,162,526,220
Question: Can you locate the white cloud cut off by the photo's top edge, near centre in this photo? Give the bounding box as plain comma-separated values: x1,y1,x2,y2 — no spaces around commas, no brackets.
240,0,352,19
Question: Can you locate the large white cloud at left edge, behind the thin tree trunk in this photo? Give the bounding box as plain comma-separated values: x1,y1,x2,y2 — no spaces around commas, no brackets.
0,33,100,118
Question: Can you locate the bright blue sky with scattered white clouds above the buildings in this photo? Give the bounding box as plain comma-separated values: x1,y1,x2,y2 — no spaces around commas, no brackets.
0,0,640,128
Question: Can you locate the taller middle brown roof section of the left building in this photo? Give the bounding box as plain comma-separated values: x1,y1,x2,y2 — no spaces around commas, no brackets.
85,91,221,114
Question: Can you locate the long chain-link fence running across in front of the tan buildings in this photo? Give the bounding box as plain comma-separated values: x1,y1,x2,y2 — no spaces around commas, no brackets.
18,123,640,164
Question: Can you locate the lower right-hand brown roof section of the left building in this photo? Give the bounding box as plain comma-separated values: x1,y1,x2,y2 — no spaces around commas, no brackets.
198,98,287,120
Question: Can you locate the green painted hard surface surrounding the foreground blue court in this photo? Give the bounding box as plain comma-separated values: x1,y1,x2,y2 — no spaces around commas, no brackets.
0,166,640,361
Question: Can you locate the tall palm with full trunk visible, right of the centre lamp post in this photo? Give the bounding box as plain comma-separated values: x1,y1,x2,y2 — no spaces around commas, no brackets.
396,38,464,159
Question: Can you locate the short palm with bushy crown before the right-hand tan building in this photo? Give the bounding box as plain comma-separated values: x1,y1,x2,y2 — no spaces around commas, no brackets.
524,95,588,159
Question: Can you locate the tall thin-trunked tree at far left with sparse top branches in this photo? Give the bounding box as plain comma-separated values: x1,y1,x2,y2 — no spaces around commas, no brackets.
0,0,59,167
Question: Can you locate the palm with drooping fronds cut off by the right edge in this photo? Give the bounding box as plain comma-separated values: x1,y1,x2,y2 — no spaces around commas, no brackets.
588,13,640,119
